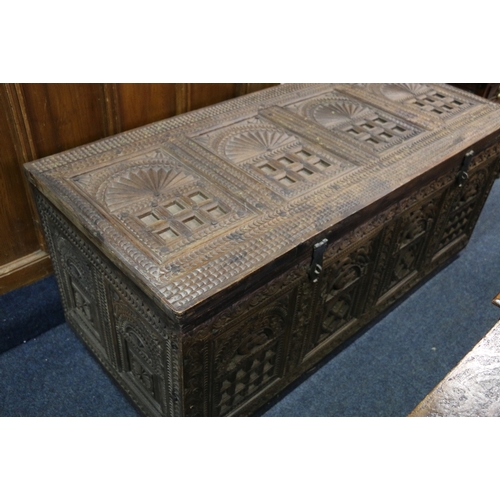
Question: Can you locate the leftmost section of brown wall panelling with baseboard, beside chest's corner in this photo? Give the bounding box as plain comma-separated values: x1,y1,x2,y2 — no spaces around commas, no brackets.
0,84,112,293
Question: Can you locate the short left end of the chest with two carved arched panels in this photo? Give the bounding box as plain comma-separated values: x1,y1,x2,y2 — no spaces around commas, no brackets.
36,194,182,416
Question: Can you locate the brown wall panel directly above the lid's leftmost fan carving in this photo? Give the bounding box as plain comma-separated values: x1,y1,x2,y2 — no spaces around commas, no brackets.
116,83,176,131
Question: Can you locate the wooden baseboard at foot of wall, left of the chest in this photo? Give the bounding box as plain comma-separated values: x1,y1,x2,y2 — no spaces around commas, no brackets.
0,250,53,295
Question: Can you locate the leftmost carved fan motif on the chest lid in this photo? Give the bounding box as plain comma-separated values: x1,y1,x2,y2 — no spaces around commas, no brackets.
103,166,193,212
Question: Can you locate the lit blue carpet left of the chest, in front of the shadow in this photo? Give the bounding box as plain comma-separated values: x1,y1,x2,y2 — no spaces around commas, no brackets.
0,324,139,417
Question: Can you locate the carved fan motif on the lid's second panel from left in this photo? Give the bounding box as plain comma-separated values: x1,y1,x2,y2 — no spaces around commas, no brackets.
224,129,296,163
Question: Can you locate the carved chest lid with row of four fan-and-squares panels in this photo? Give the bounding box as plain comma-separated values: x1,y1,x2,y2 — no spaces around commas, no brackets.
26,84,500,315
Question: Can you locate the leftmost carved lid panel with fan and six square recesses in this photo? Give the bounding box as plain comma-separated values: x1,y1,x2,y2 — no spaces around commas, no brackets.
71,148,255,264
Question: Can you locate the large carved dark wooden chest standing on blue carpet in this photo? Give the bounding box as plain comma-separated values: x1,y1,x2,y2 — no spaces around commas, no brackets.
26,84,500,416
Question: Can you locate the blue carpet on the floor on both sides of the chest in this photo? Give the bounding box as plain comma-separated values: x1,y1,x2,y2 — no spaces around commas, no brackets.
0,181,500,417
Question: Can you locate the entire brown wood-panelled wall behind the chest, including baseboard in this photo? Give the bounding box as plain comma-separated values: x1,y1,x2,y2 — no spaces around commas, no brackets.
0,83,276,293
